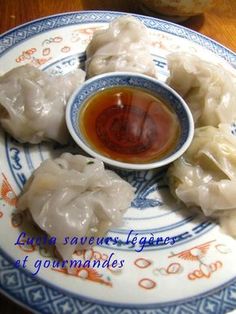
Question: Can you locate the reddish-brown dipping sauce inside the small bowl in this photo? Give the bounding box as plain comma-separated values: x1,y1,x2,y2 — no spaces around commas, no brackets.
79,87,180,163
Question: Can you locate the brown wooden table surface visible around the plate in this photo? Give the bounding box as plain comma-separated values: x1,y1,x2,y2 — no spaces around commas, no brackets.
0,0,236,314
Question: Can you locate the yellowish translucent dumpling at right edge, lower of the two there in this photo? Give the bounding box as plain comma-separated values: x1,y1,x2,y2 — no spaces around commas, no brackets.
167,124,236,236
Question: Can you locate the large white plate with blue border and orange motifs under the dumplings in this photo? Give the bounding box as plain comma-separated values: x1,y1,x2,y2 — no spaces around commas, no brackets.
0,11,236,314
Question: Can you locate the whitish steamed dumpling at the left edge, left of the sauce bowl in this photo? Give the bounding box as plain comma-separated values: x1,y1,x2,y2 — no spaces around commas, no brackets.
0,65,85,144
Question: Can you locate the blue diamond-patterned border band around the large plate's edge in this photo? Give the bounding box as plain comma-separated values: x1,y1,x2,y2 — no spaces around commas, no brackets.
0,11,236,314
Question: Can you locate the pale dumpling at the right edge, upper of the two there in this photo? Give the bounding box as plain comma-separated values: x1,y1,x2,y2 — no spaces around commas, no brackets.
167,52,236,127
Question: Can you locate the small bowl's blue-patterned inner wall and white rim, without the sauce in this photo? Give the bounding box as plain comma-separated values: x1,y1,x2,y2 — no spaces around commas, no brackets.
66,72,194,170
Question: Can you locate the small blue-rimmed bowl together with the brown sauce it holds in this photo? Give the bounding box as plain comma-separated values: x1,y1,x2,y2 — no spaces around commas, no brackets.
66,72,194,170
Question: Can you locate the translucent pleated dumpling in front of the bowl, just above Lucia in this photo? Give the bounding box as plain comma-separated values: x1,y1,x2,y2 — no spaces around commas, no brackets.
17,153,134,259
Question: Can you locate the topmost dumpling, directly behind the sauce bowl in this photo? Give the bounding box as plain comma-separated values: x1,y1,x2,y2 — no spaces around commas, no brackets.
86,15,156,77
